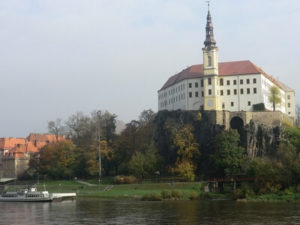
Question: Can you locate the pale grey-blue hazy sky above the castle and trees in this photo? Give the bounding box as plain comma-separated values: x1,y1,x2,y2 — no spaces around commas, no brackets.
0,0,300,137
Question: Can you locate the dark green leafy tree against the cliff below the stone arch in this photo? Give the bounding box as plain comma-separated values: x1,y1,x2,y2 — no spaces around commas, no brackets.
213,130,244,177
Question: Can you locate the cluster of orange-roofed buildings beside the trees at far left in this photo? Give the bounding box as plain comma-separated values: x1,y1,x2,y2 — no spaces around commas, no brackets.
0,134,65,178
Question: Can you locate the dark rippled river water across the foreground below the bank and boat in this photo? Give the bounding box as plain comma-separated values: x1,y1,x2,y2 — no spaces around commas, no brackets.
0,199,300,225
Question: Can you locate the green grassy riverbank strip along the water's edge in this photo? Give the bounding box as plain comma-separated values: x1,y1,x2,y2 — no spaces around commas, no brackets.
3,180,300,202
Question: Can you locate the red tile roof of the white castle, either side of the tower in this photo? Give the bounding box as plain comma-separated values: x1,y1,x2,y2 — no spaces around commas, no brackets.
160,60,285,90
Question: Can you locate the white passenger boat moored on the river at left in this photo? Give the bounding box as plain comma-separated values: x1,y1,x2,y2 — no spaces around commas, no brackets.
0,187,53,202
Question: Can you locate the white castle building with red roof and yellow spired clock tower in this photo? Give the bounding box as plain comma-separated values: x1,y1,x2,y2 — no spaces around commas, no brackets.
158,10,295,118
